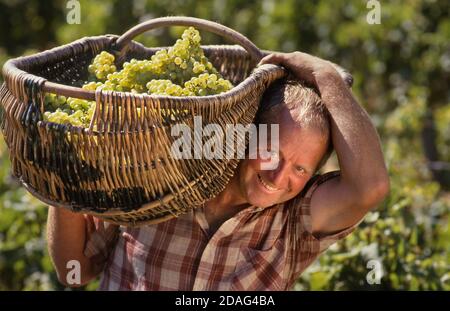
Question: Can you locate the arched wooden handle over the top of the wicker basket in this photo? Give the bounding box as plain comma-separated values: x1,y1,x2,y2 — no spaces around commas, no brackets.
116,16,264,63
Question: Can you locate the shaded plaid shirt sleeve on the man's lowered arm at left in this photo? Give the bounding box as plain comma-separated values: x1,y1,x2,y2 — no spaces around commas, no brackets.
84,217,119,266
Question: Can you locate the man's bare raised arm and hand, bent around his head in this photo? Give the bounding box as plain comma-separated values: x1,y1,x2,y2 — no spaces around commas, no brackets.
260,52,389,236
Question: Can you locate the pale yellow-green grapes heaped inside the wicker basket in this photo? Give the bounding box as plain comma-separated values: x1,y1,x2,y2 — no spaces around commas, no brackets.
44,27,233,127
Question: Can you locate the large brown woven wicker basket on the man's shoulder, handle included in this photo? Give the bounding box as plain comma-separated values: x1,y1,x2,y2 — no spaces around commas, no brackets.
0,17,285,226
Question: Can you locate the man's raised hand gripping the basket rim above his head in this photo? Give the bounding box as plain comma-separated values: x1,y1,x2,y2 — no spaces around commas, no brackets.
258,52,353,88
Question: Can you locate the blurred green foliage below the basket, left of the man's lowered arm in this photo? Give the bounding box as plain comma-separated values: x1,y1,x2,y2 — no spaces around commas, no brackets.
0,139,57,290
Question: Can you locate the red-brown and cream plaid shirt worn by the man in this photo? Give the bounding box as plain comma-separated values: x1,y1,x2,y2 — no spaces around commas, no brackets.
85,172,358,290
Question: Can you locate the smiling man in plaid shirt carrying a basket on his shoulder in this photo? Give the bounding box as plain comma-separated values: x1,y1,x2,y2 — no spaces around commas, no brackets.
48,52,389,290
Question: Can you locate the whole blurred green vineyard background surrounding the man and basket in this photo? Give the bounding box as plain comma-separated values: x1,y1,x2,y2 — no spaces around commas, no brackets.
0,0,450,290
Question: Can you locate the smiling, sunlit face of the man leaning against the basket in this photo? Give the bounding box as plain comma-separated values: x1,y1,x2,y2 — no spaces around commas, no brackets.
238,109,327,207
